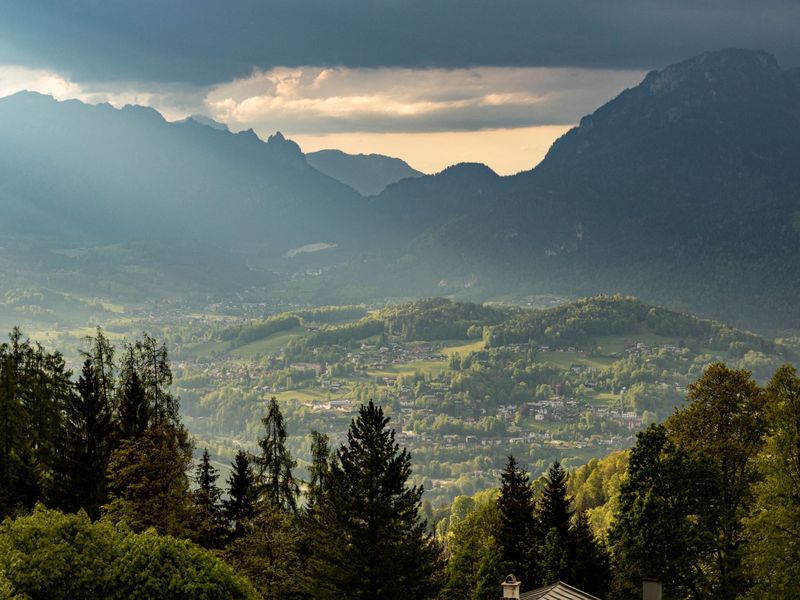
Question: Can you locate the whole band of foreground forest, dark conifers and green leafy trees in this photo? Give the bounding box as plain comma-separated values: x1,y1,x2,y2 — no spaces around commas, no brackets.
0,326,800,600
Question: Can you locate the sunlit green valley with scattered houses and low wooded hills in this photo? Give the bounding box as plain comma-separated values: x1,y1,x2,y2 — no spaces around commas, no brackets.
9,296,796,510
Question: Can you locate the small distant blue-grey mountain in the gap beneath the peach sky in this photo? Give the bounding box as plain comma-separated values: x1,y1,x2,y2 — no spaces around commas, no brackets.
306,150,423,196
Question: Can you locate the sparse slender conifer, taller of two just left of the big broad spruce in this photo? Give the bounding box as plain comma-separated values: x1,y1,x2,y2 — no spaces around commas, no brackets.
258,396,300,512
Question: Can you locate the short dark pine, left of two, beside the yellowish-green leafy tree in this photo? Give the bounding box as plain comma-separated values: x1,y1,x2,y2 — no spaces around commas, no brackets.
192,448,226,549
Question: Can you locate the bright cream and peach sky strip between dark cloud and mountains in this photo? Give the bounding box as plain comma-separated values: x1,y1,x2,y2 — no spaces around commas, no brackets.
0,65,644,174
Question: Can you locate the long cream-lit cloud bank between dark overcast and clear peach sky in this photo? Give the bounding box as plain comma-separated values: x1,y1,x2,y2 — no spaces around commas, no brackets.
205,67,643,135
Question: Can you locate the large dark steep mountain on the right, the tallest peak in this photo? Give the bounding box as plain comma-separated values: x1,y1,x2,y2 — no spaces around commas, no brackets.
405,50,800,329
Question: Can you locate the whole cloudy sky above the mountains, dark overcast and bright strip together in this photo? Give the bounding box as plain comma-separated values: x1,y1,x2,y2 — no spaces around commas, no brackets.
0,0,800,173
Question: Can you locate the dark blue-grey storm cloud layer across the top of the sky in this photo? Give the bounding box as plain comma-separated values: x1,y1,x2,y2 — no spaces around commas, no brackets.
0,0,800,85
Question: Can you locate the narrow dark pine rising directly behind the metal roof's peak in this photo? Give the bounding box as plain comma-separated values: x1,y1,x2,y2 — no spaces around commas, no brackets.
536,461,574,585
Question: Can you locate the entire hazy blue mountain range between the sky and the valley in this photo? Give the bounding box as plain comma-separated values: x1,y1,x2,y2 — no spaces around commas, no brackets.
0,50,800,331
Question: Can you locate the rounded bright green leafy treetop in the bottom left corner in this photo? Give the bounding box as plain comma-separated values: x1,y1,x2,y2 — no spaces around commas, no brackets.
0,507,259,600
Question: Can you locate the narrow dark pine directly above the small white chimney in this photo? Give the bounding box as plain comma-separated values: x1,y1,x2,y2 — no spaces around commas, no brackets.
497,456,539,589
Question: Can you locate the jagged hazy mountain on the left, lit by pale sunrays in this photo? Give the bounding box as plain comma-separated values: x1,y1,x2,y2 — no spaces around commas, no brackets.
0,93,364,255
